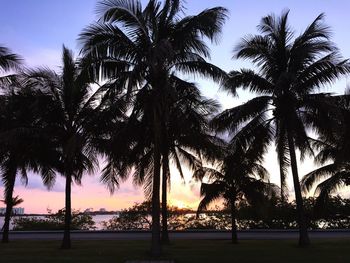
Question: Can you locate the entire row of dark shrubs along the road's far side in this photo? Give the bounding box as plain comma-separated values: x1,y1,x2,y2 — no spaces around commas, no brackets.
12,196,350,232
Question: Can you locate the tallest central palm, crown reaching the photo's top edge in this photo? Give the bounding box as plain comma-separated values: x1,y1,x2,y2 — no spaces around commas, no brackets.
80,0,227,256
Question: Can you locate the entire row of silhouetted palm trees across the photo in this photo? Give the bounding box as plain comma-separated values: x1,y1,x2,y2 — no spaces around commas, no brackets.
0,0,350,256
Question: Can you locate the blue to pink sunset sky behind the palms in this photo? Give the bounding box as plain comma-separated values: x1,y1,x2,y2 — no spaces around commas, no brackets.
0,0,350,213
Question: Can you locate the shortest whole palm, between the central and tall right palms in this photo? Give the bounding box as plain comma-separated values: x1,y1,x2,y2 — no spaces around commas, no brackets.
194,142,274,243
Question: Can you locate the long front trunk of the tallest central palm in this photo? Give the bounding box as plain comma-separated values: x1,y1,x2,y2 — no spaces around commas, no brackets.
151,109,161,257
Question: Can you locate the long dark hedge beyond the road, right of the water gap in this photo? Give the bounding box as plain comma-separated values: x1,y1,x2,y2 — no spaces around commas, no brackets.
103,196,350,230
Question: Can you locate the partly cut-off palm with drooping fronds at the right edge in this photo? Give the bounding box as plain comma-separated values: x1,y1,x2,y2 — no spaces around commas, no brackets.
301,90,350,209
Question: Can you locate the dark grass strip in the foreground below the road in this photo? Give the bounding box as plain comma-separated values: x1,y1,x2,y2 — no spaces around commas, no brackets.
0,240,350,263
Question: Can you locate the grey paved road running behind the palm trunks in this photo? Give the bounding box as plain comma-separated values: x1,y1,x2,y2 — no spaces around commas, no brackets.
0,230,350,240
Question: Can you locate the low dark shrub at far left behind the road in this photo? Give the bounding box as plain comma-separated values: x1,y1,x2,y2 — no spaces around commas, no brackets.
13,209,96,231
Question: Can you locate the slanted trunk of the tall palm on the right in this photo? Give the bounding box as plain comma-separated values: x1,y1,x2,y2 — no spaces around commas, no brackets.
288,133,310,247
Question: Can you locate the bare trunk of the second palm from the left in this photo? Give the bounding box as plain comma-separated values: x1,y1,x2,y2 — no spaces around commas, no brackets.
61,175,72,249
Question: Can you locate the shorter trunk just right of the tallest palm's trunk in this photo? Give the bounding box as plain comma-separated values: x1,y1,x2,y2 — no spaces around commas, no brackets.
162,156,169,244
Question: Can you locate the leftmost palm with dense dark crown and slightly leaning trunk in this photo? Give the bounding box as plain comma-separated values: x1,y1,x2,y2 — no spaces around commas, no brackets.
0,90,54,243
